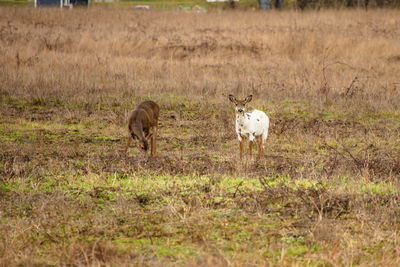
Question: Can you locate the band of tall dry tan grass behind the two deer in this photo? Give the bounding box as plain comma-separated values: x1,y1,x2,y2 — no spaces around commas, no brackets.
0,8,400,110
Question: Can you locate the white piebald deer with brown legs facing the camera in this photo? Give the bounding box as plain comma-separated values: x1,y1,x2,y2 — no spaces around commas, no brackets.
229,95,269,159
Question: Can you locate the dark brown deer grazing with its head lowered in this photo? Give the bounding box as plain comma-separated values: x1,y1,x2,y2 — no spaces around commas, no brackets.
125,100,160,157
